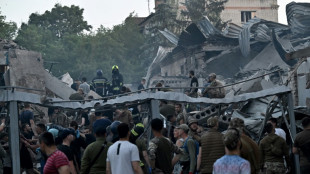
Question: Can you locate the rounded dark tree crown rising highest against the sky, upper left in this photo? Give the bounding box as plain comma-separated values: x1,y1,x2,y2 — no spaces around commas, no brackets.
28,4,92,38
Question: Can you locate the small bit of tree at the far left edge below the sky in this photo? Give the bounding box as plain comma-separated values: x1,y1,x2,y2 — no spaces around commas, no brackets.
0,12,17,40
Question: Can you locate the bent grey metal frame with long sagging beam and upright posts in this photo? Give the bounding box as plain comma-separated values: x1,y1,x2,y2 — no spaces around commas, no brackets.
0,86,299,174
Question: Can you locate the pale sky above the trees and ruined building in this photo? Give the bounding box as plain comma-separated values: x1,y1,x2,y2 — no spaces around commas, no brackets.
0,0,310,29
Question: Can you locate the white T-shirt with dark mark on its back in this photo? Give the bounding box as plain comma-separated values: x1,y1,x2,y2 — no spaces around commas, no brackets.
107,141,140,174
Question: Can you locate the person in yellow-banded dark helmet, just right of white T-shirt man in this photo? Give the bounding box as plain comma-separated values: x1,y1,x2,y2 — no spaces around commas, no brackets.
129,123,150,173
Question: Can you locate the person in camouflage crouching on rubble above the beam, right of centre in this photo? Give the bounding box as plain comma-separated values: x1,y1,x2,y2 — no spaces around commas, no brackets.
202,73,226,98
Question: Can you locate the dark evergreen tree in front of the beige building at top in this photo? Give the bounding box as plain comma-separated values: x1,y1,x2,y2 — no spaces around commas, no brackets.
182,0,228,30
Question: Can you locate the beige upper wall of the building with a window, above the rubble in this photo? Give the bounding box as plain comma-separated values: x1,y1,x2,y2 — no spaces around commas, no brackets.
221,0,278,26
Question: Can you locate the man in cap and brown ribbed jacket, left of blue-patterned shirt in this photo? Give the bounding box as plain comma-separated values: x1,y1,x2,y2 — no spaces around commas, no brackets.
197,117,225,174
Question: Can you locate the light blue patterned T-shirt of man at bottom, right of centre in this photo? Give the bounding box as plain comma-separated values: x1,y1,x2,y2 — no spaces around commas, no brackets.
212,155,251,174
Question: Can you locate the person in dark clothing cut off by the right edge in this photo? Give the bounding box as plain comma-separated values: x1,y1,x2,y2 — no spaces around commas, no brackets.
293,116,310,174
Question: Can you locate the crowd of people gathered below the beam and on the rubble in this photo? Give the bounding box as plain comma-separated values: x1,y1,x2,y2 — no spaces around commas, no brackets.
0,66,310,174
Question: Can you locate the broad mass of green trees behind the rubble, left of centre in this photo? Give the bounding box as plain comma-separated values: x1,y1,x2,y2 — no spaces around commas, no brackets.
16,4,146,83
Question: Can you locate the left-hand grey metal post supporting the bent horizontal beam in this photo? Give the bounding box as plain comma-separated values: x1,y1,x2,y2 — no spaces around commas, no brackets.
9,101,20,174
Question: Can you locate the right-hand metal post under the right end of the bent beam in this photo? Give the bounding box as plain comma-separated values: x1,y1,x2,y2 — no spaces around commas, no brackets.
287,93,300,173
